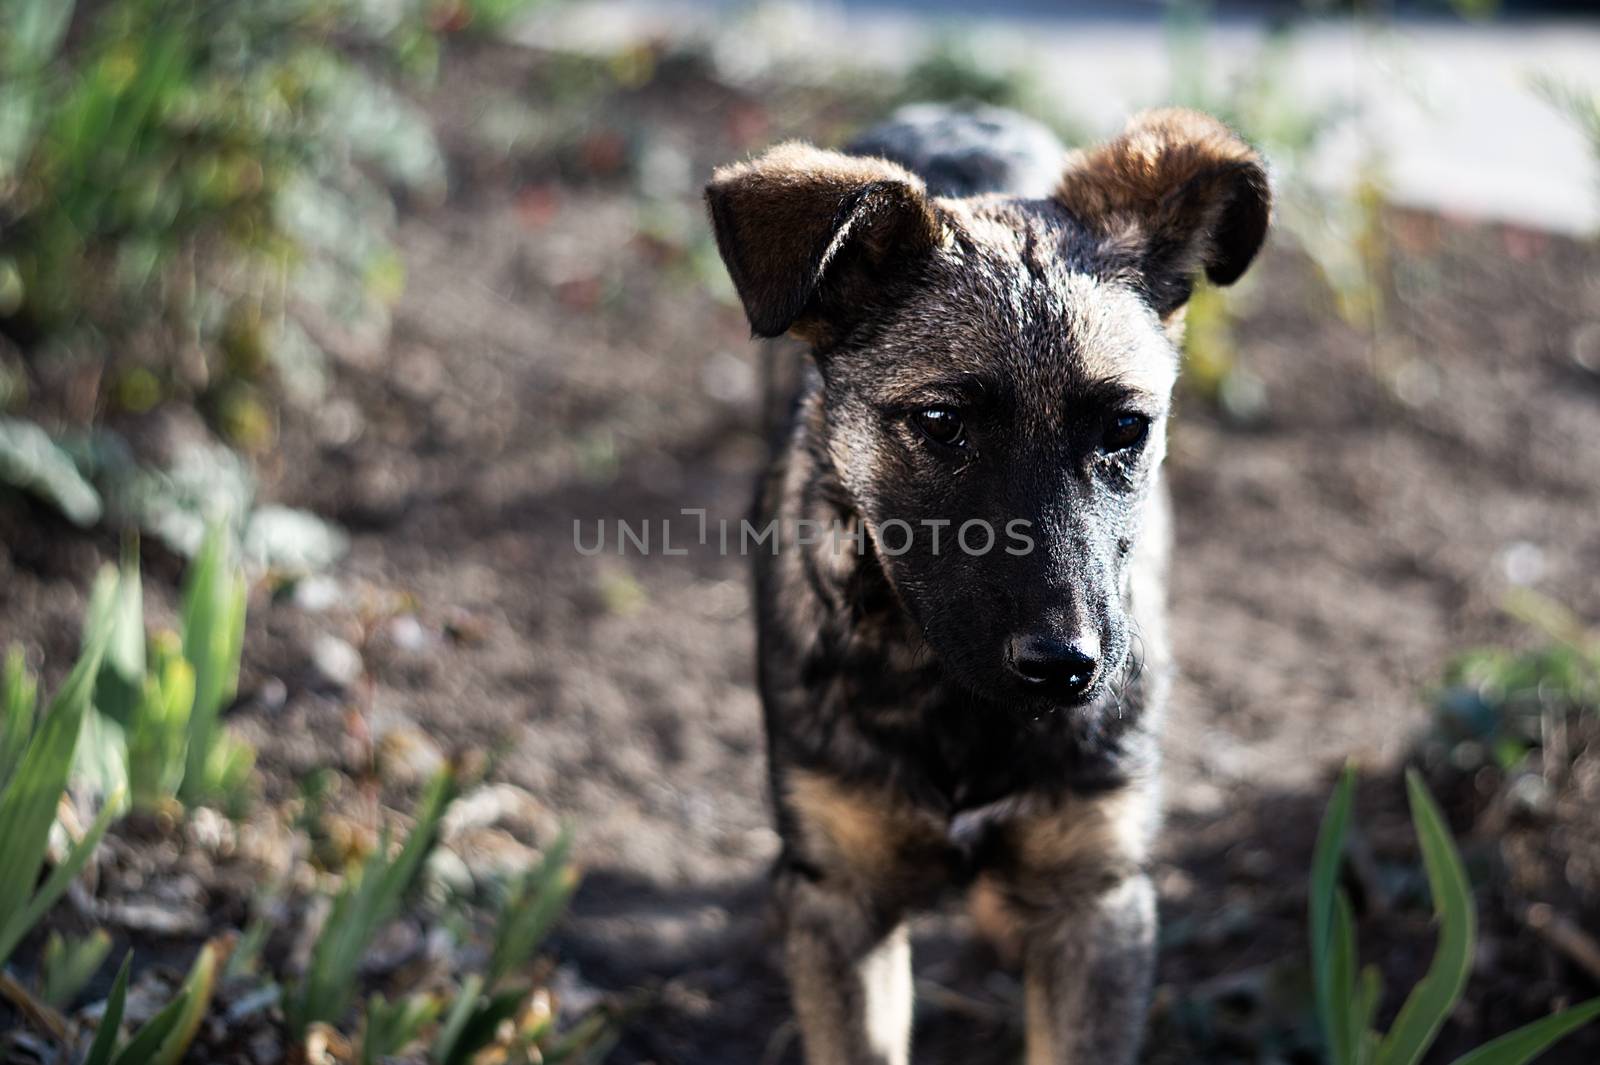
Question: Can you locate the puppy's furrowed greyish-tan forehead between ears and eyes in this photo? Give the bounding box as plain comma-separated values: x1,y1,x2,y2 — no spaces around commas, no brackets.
883,198,1178,397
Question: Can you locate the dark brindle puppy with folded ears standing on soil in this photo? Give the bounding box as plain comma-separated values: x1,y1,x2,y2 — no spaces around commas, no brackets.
706,107,1270,1065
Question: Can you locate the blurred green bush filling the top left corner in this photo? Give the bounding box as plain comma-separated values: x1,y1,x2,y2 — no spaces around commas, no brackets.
0,0,531,540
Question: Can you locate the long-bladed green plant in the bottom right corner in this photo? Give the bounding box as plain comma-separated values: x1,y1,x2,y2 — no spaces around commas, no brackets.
1310,769,1600,1065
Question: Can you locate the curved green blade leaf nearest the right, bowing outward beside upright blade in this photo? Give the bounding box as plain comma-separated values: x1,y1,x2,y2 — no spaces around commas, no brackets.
1378,769,1477,1065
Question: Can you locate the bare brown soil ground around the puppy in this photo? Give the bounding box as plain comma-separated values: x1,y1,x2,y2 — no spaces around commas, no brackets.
9,37,1600,1065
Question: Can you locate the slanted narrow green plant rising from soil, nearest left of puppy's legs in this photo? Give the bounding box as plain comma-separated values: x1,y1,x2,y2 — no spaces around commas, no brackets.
285,769,454,1033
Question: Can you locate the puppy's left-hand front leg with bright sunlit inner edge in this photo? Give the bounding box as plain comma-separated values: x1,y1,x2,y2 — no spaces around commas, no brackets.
778,873,912,1065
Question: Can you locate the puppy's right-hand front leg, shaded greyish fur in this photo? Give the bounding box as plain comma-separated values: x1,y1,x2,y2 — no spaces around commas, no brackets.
1022,875,1155,1065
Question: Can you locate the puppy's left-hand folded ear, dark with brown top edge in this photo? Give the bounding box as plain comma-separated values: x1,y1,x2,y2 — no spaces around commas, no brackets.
706,144,941,341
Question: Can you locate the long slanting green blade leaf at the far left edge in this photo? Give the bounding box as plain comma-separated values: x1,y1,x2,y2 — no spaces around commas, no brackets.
0,601,110,964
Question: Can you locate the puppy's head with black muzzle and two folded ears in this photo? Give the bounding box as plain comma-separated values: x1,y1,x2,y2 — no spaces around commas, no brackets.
707,110,1270,704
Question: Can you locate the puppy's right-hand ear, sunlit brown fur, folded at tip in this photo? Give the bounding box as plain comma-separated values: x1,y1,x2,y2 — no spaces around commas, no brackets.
1056,109,1272,318
